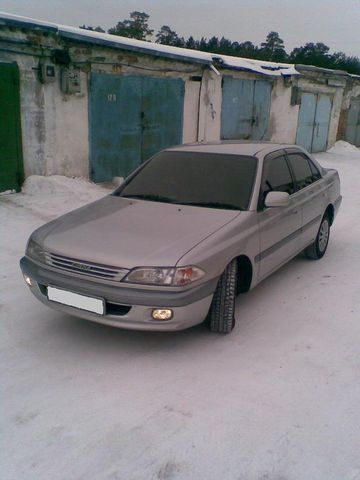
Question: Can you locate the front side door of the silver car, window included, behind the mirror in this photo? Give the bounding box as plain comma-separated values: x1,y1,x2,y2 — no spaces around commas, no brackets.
255,151,301,280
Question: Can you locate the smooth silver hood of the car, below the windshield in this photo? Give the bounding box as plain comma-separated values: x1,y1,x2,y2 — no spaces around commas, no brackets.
33,196,239,269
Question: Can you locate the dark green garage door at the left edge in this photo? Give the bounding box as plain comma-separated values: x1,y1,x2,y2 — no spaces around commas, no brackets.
0,63,23,192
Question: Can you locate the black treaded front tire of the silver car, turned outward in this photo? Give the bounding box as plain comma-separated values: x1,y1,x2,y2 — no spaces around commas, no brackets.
209,260,238,333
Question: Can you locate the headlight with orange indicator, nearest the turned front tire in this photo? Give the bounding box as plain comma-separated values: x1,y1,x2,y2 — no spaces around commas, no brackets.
123,266,205,287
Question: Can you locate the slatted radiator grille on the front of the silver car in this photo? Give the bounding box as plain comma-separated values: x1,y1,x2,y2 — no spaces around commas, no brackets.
45,252,129,282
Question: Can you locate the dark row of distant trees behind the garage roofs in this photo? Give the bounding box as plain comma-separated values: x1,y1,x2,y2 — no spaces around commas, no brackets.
80,12,360,75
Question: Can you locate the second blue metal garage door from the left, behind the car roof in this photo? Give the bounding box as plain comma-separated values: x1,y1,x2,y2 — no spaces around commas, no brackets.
221,77,271,140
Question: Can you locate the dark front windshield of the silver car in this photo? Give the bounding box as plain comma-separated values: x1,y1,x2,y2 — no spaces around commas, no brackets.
114,151,257,210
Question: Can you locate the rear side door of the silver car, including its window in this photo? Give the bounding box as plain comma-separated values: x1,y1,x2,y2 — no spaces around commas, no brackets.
286,150,326,248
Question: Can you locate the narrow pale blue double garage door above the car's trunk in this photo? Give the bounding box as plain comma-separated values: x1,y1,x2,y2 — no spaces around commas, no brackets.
296,93,332,152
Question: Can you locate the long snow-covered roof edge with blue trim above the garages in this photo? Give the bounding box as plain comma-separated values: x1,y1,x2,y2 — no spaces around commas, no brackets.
0,12,299,76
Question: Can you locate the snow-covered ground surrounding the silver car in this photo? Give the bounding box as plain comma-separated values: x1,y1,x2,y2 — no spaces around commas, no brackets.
0,142,360,480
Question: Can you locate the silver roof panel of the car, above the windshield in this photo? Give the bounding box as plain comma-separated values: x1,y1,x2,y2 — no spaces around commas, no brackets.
166,140,300,156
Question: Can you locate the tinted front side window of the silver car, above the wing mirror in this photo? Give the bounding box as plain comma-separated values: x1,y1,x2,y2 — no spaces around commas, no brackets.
259,155,295,208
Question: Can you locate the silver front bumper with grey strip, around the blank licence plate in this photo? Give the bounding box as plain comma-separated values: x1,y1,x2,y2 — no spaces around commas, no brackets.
20,257,217,331
